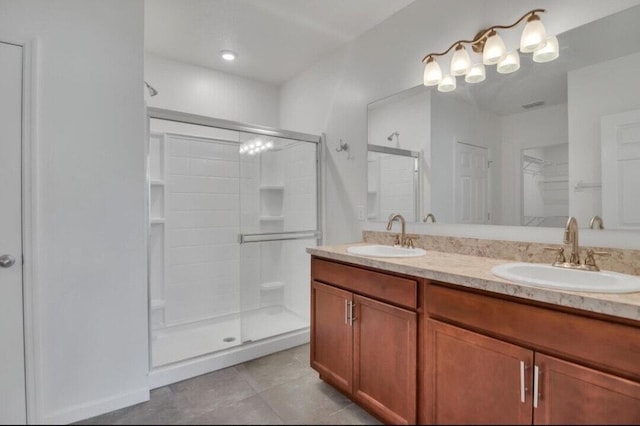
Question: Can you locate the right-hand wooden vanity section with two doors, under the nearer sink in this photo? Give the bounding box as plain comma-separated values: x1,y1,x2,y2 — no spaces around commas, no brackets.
419,284,640,424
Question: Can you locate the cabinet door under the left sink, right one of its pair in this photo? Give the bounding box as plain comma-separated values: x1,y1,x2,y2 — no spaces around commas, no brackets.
353,295,417,424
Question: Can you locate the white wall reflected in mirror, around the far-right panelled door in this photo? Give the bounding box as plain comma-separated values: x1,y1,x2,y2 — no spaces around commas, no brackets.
568,53,640,227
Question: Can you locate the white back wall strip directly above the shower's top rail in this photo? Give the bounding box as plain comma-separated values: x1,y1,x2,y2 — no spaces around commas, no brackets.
144,53,280,127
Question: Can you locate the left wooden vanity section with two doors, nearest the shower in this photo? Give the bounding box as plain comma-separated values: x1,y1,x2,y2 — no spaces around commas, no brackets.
311,257,418,424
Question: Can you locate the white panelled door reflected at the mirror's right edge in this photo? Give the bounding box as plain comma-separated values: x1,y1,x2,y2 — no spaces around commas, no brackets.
601,110,640,229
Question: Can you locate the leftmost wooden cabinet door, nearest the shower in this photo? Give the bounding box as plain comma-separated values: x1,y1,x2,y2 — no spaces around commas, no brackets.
311,281,353,394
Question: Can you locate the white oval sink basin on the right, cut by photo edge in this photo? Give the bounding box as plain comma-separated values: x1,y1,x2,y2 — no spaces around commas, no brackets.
491,263,640,293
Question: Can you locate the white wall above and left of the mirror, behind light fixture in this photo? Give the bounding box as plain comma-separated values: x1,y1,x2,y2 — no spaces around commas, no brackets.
280,0,639,243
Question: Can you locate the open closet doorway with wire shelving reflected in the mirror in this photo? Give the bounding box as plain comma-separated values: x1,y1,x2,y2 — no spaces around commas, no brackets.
520,143,569,227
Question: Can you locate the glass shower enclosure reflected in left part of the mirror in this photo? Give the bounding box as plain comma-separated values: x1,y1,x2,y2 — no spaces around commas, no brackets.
367,145,420,222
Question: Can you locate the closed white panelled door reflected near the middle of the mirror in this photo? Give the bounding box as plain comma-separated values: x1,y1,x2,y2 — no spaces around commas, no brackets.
455,142,489,223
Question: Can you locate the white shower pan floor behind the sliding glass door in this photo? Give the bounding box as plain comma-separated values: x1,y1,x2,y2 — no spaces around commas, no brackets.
151,306,309,367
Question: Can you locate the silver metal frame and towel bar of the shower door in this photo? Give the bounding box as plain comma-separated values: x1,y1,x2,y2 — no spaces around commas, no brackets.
145,107,324,372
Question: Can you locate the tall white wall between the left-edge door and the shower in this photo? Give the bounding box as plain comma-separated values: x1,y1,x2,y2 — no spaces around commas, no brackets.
0,0,148,423
